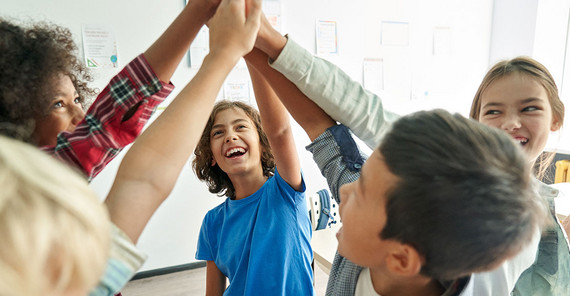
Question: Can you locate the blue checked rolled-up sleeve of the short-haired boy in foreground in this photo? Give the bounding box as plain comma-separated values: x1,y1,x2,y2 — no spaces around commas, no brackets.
307,125,365,204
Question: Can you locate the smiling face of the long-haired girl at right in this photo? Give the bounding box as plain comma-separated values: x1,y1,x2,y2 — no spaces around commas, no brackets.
479,73,558,162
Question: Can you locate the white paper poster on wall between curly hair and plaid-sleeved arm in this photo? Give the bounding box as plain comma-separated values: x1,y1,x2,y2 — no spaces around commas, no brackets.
81,24,119,69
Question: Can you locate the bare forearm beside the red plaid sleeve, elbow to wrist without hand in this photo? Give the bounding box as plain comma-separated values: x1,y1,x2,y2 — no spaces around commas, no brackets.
106,55,237,242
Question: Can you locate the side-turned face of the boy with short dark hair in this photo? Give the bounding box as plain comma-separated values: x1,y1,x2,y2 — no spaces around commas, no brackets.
337,150,398,267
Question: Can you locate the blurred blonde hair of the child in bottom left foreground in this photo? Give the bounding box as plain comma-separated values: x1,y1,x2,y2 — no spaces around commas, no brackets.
0,136,111,296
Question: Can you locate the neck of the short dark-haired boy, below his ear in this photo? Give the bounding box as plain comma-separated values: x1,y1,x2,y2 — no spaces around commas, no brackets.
370,268,445,296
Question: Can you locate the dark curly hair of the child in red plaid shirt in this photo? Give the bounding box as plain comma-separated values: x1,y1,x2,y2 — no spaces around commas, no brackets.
0,18,95,143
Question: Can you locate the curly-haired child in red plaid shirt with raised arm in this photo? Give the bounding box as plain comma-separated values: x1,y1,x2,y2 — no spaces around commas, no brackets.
0,0,220,180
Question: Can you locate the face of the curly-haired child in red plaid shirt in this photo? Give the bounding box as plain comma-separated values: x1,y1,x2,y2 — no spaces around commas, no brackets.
34,75,85,146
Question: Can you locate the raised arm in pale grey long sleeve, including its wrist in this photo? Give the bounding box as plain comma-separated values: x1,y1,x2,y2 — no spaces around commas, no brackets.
256,17,398,148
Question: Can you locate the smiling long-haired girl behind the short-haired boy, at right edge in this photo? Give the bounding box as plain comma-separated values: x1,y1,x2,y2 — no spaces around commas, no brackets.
470,57,570,295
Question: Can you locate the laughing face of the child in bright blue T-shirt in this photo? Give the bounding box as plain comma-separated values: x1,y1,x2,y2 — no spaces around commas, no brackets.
210,108,263,179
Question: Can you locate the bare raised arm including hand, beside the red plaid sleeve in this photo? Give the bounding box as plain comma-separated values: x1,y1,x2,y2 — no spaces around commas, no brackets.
106,0,261,242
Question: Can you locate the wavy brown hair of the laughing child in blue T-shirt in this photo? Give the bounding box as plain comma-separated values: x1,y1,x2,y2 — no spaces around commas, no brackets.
192,100,275,199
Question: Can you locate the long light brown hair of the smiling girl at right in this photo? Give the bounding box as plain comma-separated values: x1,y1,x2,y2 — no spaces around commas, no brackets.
469,56,564,179
